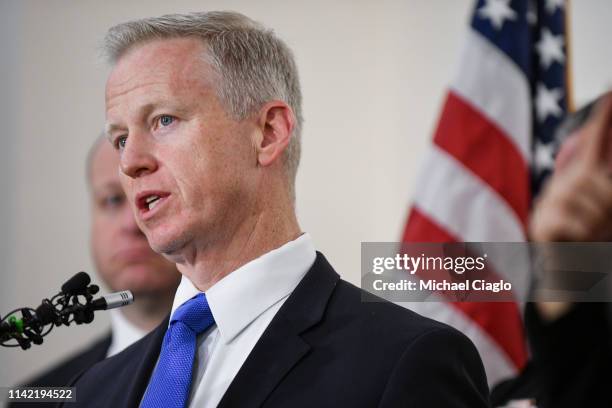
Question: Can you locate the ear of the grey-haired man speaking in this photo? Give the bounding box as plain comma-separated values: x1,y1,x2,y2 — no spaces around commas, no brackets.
256,101,295,167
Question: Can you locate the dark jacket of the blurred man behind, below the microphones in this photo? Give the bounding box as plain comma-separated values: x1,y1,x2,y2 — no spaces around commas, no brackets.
7,333,111,408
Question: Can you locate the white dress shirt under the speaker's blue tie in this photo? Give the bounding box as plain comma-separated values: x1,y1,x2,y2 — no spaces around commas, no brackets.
172,234,316,408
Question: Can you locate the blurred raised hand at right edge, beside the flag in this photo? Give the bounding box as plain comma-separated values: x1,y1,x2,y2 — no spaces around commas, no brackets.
529,93,612,242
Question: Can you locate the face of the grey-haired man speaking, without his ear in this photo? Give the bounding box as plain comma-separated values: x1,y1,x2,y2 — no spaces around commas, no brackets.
106,38,258,256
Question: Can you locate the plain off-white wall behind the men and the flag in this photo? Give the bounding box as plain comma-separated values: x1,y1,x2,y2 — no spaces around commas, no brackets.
0,0,612,385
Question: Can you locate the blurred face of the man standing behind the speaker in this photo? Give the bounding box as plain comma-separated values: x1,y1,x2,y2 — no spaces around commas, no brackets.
90,141,180,296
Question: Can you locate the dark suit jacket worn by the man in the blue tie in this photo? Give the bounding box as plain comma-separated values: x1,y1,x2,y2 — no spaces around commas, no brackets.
66,253,488,408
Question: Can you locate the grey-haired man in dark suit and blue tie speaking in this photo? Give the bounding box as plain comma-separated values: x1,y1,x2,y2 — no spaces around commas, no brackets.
65,12,488,408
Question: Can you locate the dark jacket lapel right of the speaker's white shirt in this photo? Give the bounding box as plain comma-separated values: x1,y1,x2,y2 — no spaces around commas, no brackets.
218,252,340,408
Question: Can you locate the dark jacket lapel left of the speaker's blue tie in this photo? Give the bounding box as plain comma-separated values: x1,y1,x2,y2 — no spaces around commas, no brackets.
122,317,169,408
